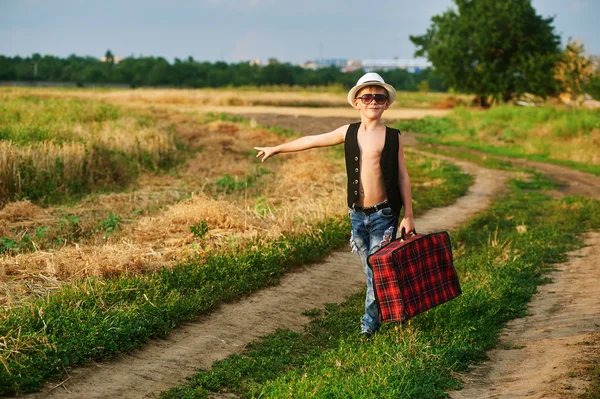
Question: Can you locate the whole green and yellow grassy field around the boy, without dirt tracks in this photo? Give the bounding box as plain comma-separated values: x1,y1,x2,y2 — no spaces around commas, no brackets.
0,88,600,398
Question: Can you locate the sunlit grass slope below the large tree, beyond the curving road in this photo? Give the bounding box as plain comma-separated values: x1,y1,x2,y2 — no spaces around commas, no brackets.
396,105,600,175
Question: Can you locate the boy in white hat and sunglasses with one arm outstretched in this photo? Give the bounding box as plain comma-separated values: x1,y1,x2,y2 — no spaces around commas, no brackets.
254,72,415,337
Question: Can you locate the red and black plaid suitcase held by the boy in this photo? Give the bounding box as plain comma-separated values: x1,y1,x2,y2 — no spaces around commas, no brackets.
368,231,462,322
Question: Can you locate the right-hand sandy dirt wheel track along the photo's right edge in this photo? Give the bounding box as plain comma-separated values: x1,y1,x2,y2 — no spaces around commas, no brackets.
451,155,600,399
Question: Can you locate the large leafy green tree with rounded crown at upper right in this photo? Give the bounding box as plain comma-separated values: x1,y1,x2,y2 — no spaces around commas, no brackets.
410,0,560,106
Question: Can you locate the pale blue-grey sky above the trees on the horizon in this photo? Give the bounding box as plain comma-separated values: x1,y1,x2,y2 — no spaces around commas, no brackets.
0,0,600,63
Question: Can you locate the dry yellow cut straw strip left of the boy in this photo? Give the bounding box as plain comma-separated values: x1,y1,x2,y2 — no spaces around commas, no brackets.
0,97,345,307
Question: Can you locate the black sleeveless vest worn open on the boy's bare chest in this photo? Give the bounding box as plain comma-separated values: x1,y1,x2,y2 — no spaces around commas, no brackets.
344,122,402,215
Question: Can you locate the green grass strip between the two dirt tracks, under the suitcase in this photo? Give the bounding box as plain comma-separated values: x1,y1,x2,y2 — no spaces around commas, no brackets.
161,175,600,399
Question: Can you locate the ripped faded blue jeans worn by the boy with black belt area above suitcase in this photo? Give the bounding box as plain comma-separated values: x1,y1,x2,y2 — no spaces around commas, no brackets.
348,208,398,333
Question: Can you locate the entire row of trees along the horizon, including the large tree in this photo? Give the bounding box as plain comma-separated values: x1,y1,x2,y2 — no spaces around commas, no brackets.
0,0,600,107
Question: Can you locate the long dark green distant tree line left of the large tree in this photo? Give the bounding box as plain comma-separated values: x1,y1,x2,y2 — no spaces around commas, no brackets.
0,50,446,91
